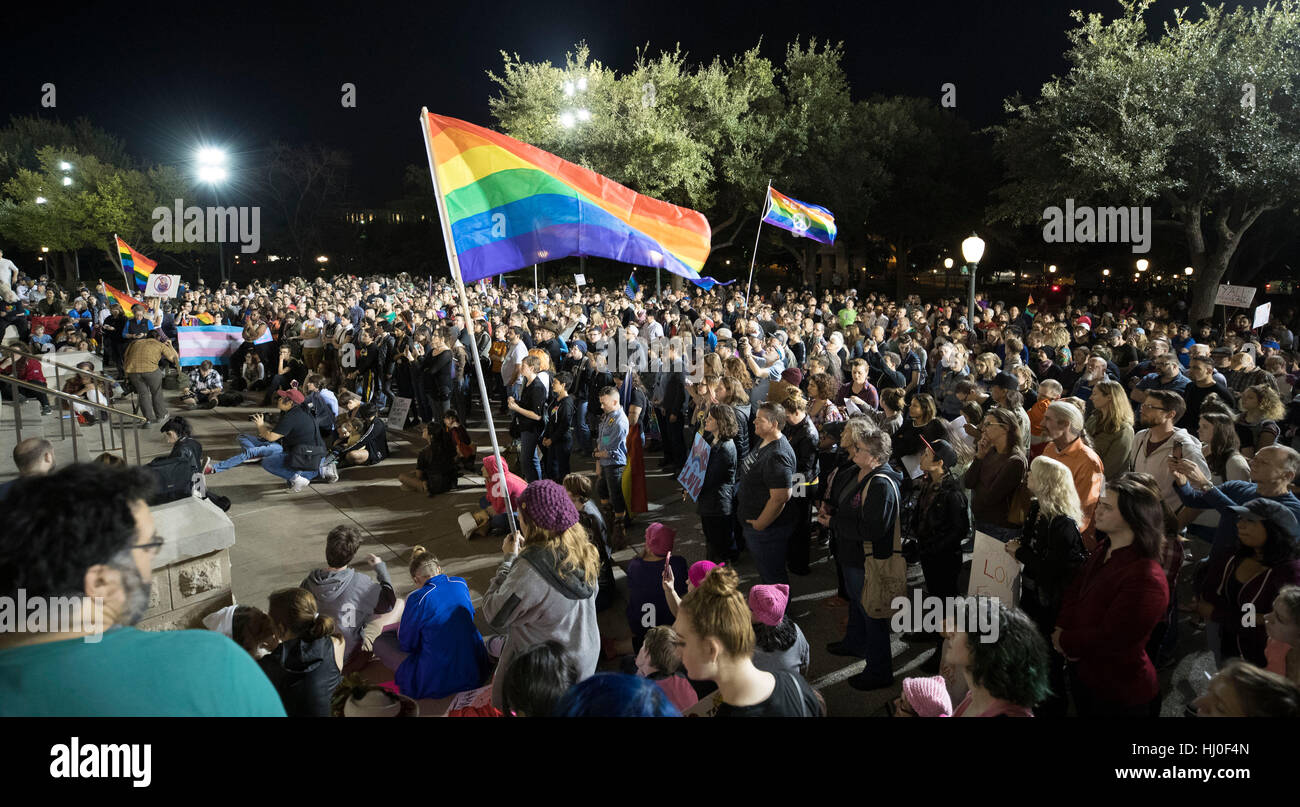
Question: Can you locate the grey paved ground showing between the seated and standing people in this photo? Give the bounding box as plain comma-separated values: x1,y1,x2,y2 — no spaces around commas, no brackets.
0,387,1213,716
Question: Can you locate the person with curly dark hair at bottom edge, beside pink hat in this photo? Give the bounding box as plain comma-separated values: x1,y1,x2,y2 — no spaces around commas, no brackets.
945,596,1050,717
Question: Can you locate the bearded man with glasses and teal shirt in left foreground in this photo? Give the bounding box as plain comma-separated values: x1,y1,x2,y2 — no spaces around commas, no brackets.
0,464,285,717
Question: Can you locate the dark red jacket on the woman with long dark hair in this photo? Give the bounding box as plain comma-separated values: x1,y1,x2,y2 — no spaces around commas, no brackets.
1057,538,1169,706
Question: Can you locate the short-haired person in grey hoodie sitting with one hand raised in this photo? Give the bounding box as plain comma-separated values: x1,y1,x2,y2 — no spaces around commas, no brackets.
299,524,402,663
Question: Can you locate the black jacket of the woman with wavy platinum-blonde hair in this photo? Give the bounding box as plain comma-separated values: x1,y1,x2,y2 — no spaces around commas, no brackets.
1015,500,1088,632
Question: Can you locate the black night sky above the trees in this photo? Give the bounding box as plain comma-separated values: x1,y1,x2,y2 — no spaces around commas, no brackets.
0,0,1182,205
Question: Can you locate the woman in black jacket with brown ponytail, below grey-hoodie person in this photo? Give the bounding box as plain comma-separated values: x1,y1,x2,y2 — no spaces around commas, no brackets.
257,589,343,717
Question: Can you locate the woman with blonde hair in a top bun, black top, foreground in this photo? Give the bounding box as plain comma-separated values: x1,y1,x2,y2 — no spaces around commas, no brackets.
672,567,826,717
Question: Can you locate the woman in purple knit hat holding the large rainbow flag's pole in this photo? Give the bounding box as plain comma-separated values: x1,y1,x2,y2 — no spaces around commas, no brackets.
482,480,601,708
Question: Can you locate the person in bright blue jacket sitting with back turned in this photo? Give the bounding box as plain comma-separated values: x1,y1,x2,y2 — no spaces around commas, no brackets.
374,546,490,699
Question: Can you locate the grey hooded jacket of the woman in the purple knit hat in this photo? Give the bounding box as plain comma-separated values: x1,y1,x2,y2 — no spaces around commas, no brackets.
481,543,601,708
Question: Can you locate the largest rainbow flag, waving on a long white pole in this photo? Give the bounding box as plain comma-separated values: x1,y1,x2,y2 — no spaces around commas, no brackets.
420,109,711,283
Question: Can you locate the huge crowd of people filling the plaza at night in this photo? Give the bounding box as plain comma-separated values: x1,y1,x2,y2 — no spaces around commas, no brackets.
0,259,1300,716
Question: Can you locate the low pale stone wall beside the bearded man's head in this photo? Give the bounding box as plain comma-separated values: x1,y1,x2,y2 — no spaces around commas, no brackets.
137,498,235,630
